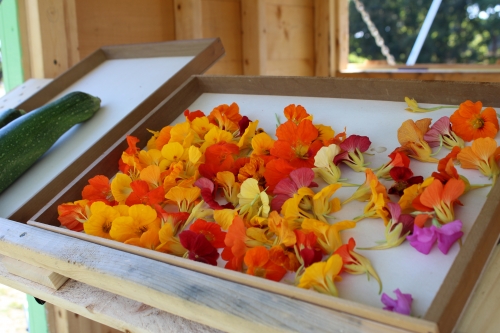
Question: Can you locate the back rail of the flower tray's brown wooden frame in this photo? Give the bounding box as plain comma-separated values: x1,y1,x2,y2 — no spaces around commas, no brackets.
195,76,500,107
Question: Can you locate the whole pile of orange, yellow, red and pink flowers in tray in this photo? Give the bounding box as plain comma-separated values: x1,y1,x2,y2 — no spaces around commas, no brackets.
58,99,500,314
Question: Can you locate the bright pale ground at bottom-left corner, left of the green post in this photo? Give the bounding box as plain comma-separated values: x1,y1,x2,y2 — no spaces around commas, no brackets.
0,284,28,333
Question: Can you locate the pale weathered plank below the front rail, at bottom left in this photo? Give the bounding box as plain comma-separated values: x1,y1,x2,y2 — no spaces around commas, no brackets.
0,254,220,333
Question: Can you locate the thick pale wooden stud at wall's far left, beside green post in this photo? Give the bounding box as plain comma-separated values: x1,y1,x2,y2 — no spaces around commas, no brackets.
25,0,69,78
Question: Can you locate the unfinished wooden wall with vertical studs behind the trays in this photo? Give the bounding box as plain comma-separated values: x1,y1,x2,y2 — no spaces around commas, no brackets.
17,0,500,81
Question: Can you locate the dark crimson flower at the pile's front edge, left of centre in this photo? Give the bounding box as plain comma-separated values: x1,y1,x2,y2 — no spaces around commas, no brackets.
179,230,219,266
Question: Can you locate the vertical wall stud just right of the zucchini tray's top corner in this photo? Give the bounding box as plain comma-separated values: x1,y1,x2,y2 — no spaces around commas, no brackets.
241,0,267,75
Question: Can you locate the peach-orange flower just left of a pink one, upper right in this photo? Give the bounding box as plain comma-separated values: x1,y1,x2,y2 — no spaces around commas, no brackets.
398,118,438,163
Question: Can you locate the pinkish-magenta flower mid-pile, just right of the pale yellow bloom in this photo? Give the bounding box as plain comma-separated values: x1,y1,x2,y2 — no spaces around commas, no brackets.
271,168,318,212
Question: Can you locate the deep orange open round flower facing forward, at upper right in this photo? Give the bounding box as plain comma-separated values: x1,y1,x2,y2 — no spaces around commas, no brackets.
450,101,498,141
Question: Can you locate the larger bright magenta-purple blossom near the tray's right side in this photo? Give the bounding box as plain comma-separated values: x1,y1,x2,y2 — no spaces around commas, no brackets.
406,220,464,254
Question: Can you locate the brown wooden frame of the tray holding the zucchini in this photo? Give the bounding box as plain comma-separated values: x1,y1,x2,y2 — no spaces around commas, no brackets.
8,38,224,222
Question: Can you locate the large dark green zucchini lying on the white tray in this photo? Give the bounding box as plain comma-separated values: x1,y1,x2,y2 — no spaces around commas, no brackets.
0,92,101,193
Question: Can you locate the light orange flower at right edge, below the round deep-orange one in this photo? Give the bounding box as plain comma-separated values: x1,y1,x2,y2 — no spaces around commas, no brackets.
457,138,500,184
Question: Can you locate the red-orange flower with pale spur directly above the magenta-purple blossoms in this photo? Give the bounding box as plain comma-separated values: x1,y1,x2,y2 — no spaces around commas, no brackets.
413,178,465,228
